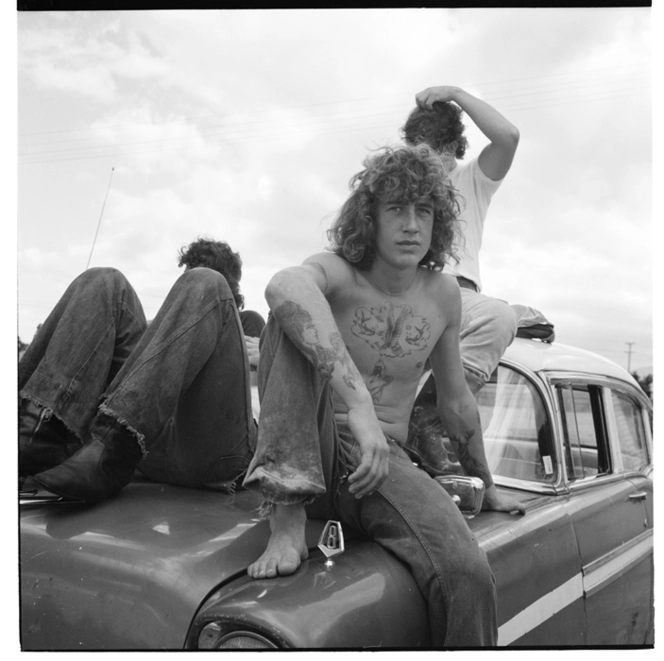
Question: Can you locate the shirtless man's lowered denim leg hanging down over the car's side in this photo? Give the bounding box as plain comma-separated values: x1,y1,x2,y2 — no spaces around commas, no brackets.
337,430,498,647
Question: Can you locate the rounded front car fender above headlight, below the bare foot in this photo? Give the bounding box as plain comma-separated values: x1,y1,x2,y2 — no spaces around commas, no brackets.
186,540,430,649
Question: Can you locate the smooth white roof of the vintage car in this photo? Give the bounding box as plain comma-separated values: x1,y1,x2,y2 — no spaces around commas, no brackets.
504,338,638,385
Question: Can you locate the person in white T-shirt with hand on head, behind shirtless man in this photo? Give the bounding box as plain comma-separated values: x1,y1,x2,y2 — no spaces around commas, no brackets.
401,85,519,395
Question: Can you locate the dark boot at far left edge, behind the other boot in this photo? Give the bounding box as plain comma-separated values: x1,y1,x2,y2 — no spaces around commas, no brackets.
18,399,82,478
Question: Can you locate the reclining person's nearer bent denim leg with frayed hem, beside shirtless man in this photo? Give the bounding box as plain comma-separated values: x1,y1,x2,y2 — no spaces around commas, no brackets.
103,268,256,491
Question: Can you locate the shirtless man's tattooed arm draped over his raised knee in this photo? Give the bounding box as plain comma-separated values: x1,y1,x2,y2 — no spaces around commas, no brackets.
265,255,389,498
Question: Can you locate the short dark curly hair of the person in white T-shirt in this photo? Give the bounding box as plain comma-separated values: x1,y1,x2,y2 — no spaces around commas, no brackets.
401,101,468,159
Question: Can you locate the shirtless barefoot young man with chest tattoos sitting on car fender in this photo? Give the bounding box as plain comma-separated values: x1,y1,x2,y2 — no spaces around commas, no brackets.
245,145,523,646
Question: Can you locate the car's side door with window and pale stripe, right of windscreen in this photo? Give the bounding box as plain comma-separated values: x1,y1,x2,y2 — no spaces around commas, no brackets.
556,377,652,645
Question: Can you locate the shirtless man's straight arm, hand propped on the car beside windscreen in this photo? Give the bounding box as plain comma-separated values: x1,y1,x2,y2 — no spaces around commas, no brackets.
430,283,525,512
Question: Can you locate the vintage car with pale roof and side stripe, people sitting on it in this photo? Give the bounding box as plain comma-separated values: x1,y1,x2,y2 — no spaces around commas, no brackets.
20,339,653,650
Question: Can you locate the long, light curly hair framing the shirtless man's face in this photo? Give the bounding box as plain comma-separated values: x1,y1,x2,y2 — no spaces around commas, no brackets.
327,144,459,271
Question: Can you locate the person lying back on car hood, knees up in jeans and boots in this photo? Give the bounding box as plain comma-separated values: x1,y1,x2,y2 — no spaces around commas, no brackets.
18,241,256,501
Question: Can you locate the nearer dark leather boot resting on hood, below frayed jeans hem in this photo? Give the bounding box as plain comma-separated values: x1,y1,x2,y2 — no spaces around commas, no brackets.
33,423,142,501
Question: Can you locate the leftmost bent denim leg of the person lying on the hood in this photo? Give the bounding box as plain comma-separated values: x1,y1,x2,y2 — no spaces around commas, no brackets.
18,268,147,441
